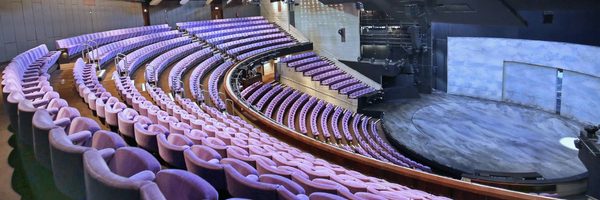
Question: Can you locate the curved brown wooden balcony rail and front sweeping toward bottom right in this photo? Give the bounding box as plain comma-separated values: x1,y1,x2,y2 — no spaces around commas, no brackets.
225,42,553,200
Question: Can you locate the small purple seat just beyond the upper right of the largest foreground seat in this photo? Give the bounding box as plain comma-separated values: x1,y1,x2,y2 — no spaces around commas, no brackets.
156,133,194,169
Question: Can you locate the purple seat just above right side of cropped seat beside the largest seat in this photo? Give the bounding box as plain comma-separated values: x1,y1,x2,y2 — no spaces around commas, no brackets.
183,145,227,190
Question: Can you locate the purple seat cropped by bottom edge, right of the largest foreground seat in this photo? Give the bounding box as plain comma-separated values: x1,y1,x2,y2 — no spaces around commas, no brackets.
155,169,219,200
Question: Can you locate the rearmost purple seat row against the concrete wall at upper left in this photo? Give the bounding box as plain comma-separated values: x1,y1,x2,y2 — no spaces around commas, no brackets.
56,24,171,56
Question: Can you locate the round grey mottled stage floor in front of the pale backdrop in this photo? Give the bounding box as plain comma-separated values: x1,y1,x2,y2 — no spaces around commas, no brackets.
369,93,587,179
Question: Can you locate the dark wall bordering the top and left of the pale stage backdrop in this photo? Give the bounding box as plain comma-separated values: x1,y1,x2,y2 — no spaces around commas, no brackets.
431,10,600,91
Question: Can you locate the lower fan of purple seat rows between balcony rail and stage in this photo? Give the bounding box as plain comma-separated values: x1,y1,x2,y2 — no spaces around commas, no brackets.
240,81,431,171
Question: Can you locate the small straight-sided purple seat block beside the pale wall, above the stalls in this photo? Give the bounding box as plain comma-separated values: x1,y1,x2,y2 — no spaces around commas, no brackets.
279,52,376,99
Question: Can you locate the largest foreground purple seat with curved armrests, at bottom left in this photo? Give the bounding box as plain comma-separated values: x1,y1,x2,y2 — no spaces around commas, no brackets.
83,147,160,200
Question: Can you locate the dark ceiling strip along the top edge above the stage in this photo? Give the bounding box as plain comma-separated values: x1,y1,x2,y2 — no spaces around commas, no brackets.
318,0,600,26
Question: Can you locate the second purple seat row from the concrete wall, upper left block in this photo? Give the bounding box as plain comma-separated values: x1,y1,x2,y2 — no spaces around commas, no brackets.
87,30,182,66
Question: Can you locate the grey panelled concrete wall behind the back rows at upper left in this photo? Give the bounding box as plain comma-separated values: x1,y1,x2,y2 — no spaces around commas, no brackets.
0,0,144,62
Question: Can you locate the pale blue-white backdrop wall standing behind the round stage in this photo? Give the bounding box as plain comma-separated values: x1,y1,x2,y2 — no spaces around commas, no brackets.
447,37,600,123
